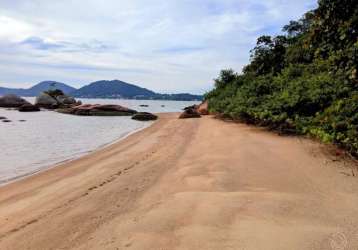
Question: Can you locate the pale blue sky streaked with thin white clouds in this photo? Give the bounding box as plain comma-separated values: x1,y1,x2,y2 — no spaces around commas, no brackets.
0,0,317,94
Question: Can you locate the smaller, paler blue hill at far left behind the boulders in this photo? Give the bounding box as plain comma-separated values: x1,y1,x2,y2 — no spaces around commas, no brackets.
0,81,76,96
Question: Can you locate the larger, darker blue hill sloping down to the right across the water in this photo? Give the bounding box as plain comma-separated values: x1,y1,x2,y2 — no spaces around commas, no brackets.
71,80,202,101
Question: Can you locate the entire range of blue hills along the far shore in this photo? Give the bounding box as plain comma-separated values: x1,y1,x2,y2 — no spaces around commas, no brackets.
0,80,203,101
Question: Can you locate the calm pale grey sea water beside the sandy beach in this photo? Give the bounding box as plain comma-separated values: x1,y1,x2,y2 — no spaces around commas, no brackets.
0,98,197,185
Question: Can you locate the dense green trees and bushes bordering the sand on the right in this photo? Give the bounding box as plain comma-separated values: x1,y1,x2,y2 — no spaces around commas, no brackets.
205,0,358,156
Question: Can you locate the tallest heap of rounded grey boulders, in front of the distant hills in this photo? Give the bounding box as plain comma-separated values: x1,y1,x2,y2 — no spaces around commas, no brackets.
35,90,82,109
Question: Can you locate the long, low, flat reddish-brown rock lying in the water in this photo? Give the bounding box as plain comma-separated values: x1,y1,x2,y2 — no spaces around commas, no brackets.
56,104,137,116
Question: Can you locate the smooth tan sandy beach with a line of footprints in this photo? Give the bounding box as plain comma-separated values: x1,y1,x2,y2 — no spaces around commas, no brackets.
0,114,358,250
